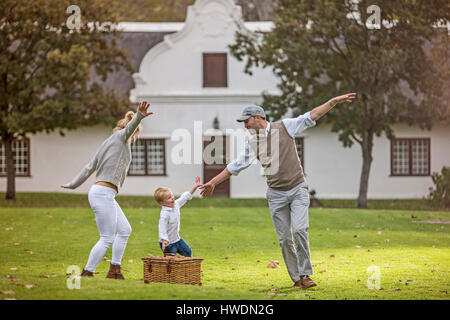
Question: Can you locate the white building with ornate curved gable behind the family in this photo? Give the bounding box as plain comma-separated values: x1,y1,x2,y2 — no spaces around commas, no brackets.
0,0,450,199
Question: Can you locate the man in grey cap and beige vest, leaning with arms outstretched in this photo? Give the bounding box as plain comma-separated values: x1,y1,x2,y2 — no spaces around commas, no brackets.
200,93,356,288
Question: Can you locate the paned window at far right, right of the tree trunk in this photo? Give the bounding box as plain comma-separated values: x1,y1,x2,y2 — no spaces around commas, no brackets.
391,138,430,176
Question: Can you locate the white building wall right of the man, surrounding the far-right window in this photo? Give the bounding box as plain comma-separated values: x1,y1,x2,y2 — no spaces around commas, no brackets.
304,125,450,199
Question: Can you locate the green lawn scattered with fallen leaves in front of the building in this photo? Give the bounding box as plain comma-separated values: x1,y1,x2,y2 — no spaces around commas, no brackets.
0,205,450,300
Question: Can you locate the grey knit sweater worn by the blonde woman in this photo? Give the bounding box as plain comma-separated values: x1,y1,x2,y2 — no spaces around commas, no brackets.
63,111,145,189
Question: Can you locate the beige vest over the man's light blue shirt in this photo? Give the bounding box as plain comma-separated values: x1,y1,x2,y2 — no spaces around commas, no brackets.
249,121,305,191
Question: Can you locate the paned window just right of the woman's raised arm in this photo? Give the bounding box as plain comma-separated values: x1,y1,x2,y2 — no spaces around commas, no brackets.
128,139,166,176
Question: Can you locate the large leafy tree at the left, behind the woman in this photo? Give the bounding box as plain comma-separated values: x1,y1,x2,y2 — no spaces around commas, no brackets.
0,0,132,200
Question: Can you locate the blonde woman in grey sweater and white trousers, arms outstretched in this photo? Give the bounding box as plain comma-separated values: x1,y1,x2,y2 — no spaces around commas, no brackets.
62,101,153,279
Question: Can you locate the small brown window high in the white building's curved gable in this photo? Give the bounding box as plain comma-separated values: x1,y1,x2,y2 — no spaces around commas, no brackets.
203,53,228,88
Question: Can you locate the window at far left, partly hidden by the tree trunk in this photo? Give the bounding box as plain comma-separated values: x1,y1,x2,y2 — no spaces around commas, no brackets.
0,139,30,177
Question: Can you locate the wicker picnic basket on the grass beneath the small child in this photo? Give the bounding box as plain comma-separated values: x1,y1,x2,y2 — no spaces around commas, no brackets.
142,256,203,286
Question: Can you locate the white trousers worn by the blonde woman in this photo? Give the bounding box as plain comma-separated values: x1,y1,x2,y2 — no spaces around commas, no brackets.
84,185,131,272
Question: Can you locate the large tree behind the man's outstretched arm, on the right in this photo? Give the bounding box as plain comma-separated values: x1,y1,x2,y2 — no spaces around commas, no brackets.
230,0,450,208
